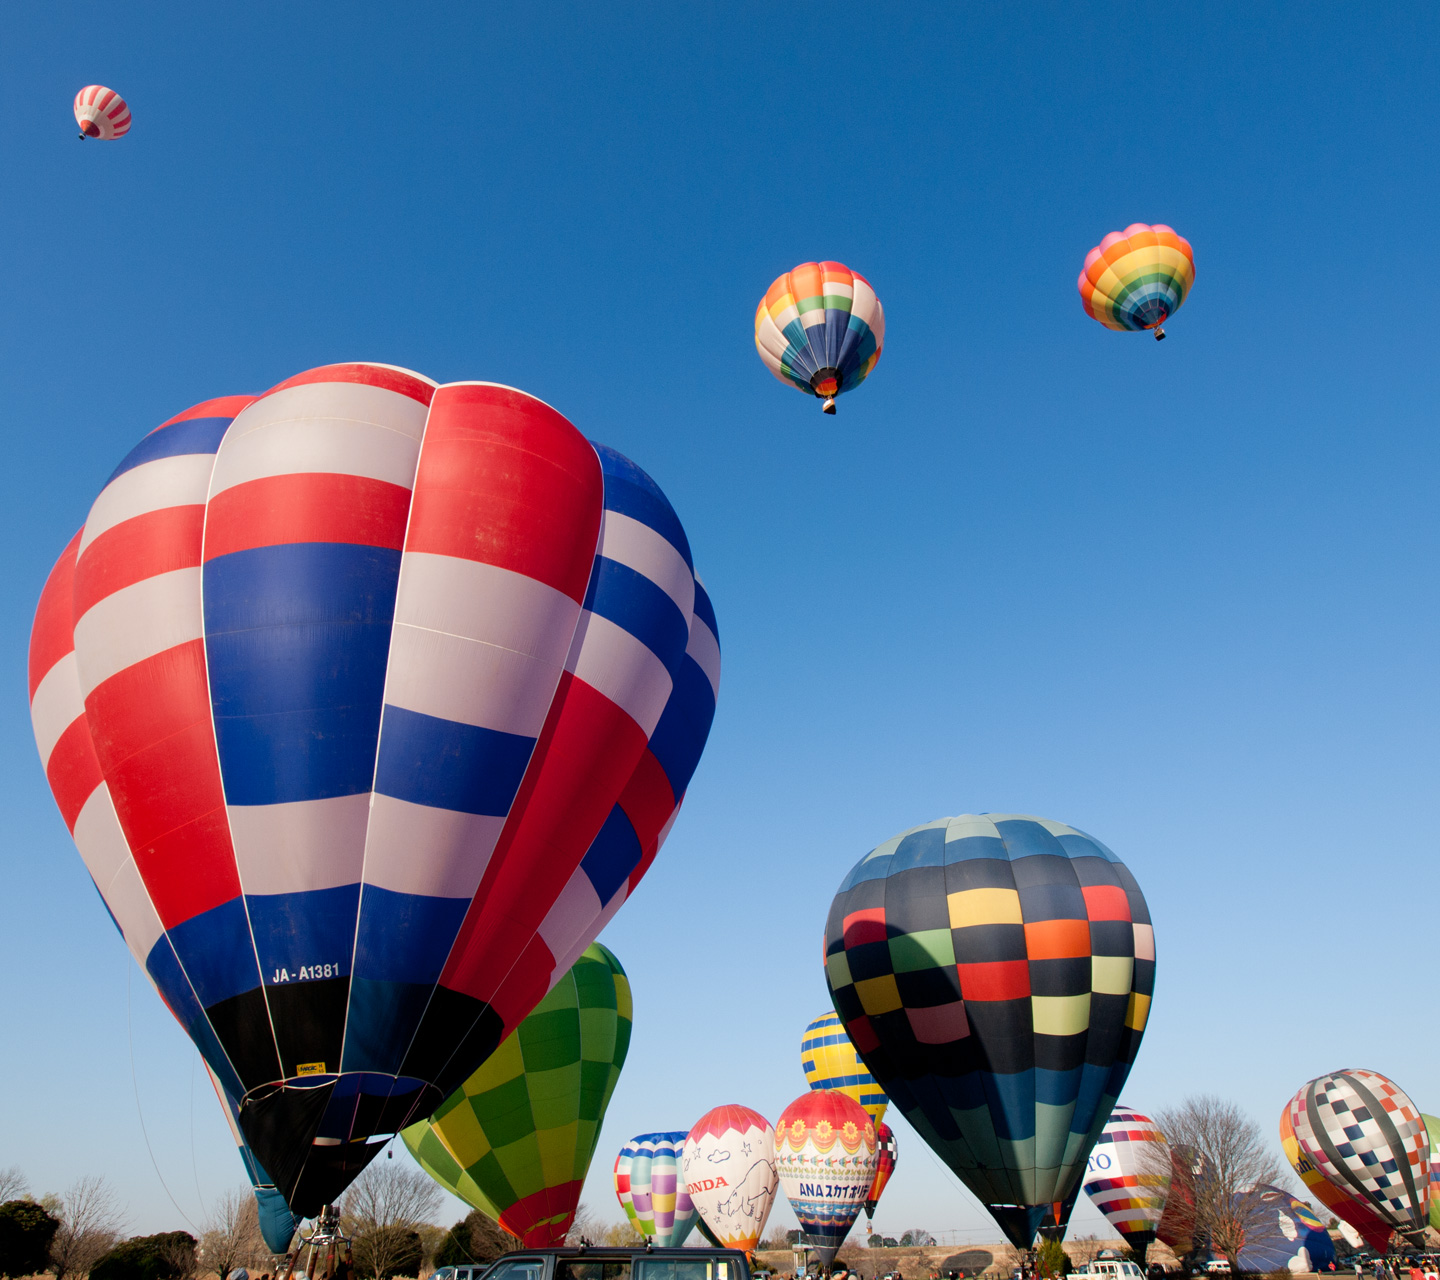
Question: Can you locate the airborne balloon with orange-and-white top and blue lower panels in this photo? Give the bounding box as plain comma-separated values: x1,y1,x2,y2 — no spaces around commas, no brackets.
755,262,886,413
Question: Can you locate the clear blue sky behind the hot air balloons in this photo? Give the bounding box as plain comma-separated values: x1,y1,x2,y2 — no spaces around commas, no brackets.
0,3,1440,1238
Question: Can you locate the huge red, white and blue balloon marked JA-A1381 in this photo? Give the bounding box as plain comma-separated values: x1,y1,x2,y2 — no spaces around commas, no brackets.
30,364,720,1217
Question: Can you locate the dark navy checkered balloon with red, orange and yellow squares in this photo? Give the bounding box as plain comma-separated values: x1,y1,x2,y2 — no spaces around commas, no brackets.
825,813,1155,1248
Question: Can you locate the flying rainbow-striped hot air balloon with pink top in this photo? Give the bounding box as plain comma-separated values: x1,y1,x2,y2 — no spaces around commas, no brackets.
1077,222,1195,341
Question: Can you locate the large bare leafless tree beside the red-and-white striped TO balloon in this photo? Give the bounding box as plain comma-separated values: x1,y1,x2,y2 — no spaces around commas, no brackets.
1145,1094,1282,1276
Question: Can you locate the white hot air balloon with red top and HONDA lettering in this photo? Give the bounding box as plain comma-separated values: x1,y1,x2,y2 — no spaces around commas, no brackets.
681,1104,778,1253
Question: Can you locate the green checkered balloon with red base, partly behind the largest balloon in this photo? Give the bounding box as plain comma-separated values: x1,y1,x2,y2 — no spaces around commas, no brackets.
402,943,632,1248
